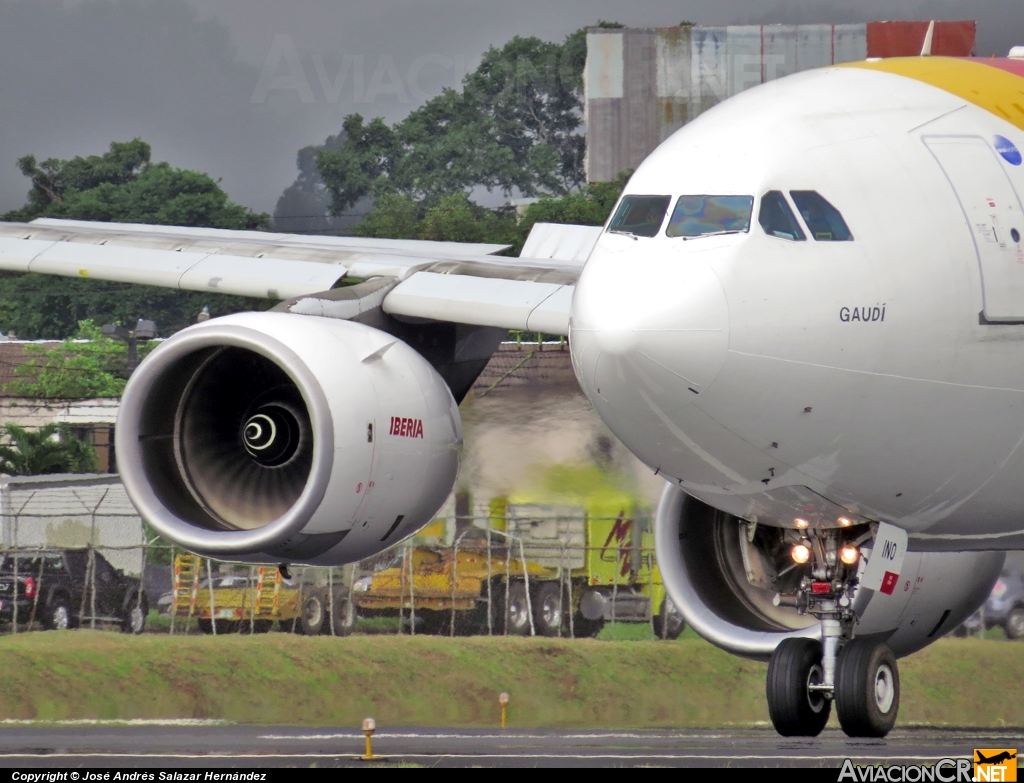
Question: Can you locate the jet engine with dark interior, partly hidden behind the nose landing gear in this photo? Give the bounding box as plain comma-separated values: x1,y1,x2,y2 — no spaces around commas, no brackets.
655,484,1006,660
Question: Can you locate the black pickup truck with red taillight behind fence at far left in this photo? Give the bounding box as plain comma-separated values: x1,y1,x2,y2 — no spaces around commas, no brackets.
0,550,150,634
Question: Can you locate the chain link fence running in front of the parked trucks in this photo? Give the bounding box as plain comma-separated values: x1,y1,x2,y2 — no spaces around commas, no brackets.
0,476,664,638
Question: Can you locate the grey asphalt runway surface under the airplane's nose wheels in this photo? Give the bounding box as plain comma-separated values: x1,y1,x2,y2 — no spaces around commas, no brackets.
0,722,1024,770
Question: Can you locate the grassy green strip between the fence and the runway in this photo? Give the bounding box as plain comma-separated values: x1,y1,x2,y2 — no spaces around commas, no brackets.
0,630,1024,729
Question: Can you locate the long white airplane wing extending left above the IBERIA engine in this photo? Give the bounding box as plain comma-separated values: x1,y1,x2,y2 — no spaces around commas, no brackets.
0,218,602,335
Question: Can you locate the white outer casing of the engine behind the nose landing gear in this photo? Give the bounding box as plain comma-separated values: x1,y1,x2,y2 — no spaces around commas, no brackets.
655,484,1006,660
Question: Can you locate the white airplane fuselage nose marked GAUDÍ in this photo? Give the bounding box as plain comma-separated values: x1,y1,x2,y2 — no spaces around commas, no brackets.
570,58,1024,551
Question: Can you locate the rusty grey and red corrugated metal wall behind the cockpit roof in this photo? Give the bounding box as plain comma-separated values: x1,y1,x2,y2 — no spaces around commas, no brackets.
584,21,974,182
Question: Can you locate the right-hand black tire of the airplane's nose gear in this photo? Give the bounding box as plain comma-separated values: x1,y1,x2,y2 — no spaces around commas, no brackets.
836,639,899,737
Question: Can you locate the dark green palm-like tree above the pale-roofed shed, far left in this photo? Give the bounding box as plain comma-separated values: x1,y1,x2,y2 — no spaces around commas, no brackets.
0,423,96,476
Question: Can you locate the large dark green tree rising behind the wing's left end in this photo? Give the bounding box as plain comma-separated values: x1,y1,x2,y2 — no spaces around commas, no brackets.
0,139,268,339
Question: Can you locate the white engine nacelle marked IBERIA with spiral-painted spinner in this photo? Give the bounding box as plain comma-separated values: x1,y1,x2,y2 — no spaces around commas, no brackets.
116,312,462,565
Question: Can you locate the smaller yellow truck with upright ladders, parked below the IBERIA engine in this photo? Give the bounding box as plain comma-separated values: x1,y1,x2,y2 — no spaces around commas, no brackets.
170,554,355,636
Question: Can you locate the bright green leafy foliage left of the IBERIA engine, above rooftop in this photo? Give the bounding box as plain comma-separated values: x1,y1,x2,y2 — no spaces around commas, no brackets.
4,320,154,399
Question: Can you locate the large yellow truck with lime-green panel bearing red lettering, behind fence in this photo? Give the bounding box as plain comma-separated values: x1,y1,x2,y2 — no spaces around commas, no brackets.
352,505,684,639
